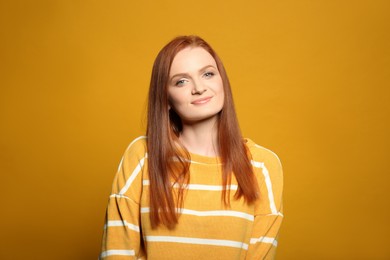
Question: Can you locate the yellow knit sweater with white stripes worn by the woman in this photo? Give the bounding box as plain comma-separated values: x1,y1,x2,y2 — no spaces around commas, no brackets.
100,136,283,260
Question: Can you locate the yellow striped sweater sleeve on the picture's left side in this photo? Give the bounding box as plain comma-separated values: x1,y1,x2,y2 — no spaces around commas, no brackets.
99,137,146,260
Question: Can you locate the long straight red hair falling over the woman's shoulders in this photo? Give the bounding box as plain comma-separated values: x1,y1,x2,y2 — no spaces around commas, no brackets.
147,35,258,228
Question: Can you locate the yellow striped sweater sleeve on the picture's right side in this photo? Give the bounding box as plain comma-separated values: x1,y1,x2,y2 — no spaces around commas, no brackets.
247,154,283,259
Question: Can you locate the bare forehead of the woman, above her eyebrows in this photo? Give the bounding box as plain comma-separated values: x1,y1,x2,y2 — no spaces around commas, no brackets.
169,47,217,75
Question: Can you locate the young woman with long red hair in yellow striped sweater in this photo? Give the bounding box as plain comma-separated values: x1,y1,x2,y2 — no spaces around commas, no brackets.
100,36,283,259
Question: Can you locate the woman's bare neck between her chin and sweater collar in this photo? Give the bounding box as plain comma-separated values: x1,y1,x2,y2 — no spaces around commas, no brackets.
179,119,219,157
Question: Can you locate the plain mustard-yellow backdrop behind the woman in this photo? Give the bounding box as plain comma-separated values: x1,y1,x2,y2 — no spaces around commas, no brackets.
0,0,390,259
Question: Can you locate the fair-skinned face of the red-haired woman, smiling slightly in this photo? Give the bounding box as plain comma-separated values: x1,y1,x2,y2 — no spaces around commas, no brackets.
168,47,224,124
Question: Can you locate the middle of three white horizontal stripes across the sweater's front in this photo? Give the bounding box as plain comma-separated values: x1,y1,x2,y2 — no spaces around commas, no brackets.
141,208,254,221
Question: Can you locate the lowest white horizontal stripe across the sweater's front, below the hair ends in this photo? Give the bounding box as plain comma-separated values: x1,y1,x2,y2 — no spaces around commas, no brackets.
145,236,248,250
